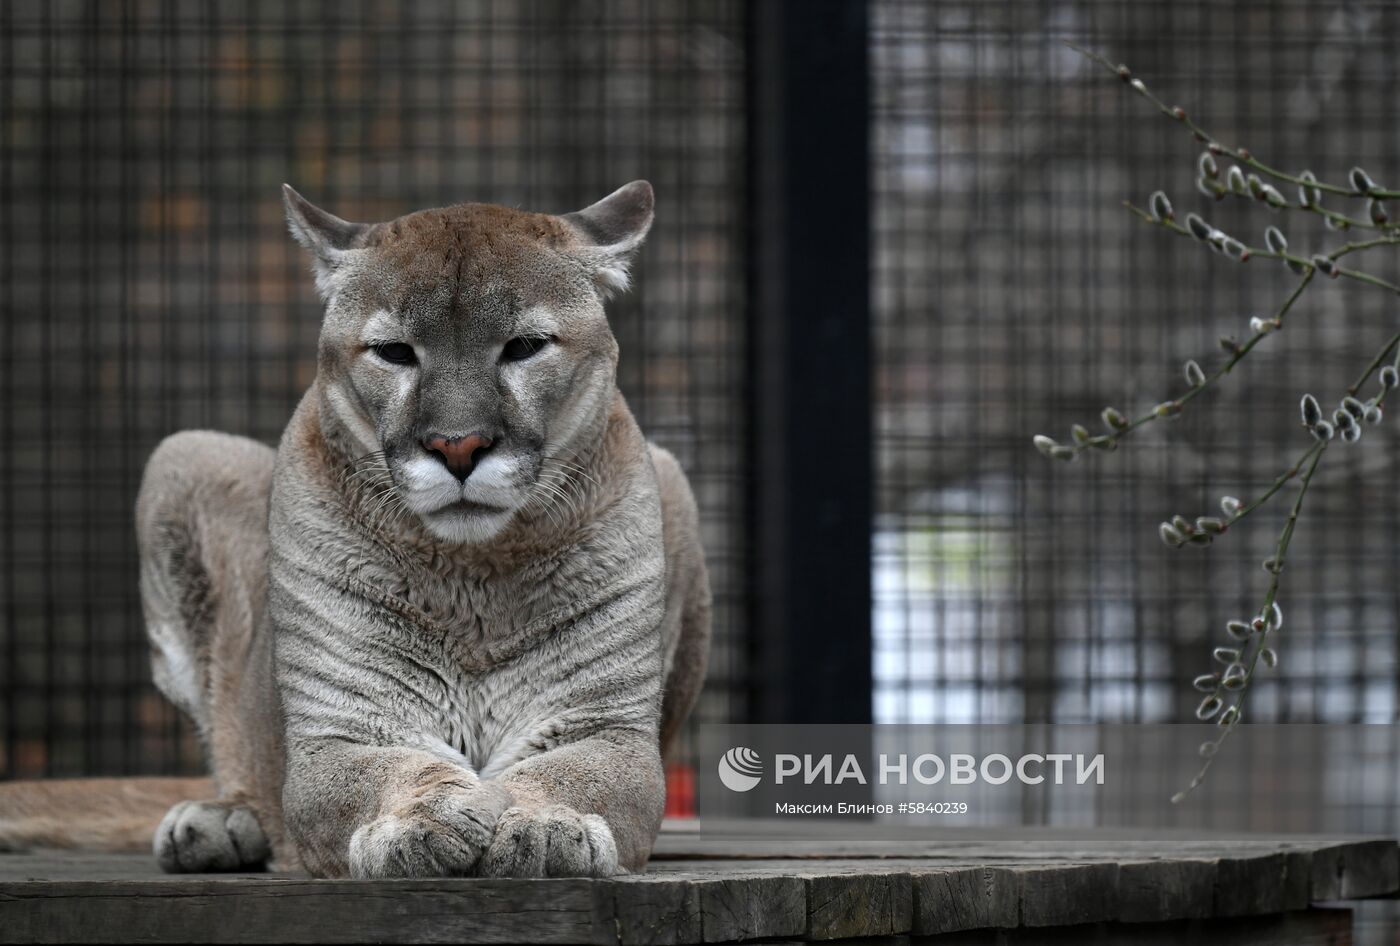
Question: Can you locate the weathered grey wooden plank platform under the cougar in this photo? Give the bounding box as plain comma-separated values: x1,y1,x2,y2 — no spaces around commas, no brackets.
0,821,1400,943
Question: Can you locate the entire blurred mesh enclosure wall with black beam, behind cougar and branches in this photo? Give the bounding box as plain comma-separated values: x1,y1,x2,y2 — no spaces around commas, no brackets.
0,0,1400,828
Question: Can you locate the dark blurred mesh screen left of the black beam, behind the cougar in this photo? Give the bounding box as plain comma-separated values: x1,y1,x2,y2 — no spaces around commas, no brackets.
0,0,745,777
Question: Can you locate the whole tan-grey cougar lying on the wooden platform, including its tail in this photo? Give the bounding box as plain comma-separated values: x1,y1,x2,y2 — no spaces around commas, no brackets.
0,181,710,877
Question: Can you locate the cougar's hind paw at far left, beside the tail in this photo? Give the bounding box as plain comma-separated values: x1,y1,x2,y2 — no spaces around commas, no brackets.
155,802,272,873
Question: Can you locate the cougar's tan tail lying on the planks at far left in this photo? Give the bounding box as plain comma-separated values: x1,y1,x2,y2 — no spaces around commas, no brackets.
0,778,214,851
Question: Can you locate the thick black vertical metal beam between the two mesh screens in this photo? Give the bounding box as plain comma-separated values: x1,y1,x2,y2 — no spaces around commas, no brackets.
749,0,874,722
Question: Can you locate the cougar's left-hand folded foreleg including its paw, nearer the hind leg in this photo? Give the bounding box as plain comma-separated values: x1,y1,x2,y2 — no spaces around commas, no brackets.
283,740,510,877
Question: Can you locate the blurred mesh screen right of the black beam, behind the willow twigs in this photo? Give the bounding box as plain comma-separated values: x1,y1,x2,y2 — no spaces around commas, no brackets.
872,0,1400,722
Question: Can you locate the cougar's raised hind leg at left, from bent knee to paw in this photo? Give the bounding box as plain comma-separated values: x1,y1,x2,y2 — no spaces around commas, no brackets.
136,431,281,872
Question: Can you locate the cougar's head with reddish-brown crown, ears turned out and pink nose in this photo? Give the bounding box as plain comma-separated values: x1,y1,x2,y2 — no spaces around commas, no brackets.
284,181,652,543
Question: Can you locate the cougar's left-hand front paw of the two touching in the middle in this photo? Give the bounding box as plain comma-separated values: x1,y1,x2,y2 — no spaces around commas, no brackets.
350,789,505,877
